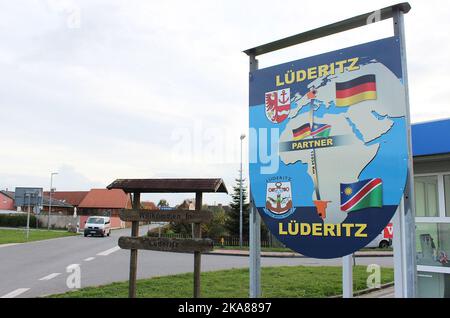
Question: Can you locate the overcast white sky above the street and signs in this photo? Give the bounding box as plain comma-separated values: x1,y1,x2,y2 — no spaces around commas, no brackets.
0,0,450,204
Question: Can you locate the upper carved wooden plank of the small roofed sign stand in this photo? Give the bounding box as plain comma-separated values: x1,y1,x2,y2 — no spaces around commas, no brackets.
120,210,213,223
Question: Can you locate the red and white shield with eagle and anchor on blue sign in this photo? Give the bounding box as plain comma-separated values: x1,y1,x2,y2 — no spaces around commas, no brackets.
265,88,291,124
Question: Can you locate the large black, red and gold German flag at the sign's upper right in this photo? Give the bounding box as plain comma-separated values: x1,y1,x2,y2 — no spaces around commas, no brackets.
336,74,377,107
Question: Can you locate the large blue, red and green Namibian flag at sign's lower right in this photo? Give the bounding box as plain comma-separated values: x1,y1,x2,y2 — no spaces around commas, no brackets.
341,178,383,212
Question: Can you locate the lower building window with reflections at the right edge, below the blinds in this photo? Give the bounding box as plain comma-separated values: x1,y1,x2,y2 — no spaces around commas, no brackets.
416,223,450,268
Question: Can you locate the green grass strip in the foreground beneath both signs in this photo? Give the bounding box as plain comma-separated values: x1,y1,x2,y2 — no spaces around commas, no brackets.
50,266,394,298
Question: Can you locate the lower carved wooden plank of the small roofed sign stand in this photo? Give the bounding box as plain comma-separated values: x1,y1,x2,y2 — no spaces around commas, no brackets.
119,236,214,253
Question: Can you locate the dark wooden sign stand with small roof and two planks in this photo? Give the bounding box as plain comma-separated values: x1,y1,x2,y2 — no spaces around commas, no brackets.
107,179,228,298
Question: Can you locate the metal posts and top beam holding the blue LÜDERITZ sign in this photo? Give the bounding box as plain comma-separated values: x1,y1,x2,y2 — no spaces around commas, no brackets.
244,2,417,298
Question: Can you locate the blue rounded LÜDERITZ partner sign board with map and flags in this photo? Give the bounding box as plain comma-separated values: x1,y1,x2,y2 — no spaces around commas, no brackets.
250,37,408,258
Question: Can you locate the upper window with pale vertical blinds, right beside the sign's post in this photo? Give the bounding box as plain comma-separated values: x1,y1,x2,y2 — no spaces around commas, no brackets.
414,176,439,217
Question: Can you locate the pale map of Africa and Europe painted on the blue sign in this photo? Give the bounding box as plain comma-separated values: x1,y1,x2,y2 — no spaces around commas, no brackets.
280,61,405,224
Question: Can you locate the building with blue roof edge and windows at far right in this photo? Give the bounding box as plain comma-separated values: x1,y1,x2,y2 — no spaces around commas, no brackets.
412,119,450,298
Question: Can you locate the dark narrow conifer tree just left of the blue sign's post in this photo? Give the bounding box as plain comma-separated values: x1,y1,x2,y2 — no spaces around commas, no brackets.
225,179,250,238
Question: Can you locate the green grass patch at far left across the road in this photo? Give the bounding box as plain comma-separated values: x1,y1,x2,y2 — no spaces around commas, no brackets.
0,229,77,244
